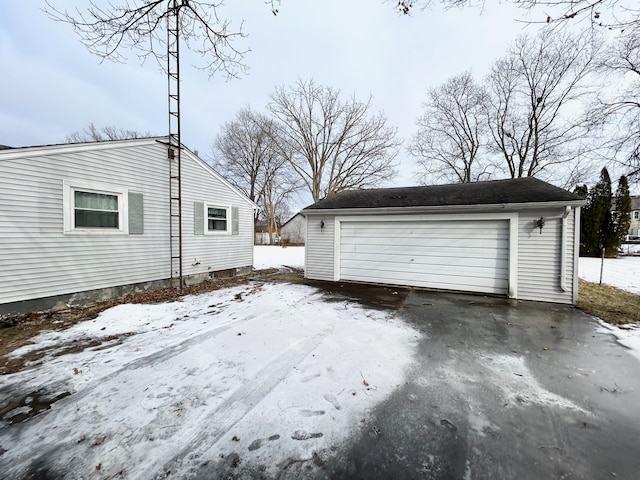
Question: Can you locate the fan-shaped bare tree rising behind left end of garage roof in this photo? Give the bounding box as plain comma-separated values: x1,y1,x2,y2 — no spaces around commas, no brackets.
268,80,400,202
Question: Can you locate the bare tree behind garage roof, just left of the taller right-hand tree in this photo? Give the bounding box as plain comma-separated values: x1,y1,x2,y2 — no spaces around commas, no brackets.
409,72,490,183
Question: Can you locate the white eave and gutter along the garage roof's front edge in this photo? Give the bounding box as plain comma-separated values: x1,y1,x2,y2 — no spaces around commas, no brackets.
300,200,587,216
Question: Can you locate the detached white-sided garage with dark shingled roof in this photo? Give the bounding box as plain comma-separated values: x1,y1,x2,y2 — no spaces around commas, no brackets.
303,178,585,304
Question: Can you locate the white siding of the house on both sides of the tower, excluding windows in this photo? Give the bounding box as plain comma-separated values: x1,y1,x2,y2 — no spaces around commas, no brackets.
0,140,253,304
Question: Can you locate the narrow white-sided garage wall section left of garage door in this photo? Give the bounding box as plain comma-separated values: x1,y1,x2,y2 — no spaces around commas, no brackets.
304,214,335,281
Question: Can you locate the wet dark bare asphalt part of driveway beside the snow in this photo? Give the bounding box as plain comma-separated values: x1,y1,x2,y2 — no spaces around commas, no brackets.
300,291,640,479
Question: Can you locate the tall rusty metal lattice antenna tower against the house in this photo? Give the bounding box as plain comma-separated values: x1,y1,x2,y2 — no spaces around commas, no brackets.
167,0,184,288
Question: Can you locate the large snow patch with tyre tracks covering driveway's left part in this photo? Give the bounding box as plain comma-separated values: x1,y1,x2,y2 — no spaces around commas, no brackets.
0,284,419,479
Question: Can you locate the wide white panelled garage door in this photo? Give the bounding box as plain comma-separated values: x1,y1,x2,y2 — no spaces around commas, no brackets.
340,220,509,294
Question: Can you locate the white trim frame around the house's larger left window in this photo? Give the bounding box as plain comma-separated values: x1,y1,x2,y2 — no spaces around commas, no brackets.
62,180,129,235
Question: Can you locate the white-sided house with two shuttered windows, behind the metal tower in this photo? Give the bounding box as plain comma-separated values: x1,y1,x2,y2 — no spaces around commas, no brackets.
0,137,257,315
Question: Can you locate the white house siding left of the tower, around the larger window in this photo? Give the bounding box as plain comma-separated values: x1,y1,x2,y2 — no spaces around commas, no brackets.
0,142,169,303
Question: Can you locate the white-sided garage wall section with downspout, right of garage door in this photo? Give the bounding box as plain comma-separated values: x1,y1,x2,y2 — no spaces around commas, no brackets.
518,209,575,304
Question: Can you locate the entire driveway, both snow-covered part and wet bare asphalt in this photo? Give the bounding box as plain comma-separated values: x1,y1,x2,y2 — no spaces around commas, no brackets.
0,282,640,480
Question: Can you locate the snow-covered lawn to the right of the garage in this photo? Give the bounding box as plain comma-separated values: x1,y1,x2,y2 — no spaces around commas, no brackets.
578,257,640,295
